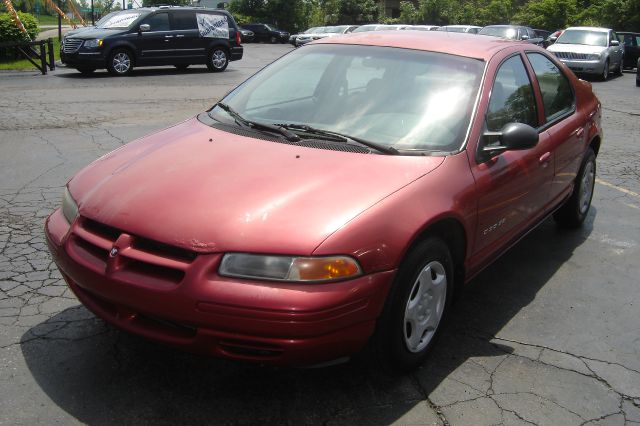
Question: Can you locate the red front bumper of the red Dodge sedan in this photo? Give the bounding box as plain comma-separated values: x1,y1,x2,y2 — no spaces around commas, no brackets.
45,210,394,366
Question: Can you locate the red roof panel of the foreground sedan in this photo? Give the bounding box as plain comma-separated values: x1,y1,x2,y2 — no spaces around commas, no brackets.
312,31,534,61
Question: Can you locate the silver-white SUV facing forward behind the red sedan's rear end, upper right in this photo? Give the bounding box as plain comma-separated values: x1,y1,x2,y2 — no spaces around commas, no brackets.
548,27,624,80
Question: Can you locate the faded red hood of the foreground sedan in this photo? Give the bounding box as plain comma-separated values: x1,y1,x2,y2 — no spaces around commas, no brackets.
68,118,444,255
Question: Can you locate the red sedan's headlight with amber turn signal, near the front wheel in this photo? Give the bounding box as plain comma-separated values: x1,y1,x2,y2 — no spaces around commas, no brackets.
218,253,362,282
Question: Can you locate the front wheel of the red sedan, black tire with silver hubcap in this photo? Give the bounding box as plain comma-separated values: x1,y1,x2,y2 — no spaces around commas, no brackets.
372,237,454,371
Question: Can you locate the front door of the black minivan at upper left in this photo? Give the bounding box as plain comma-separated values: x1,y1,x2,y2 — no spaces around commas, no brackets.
135,11,174,65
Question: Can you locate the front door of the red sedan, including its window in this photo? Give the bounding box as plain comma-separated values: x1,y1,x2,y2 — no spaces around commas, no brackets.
470,53,553,263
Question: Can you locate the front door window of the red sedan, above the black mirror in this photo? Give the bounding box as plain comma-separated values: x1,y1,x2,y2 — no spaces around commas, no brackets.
487,55,538,132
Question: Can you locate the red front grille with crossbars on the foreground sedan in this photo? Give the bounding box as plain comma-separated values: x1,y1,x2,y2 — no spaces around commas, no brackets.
68,217,197,288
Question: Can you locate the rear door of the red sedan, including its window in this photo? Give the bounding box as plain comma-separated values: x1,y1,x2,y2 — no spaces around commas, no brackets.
526,52,587,204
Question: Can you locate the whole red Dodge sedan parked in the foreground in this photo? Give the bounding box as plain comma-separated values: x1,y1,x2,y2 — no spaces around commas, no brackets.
45,31,602,370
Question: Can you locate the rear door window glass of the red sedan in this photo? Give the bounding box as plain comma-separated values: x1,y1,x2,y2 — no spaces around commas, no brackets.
527,53,575,122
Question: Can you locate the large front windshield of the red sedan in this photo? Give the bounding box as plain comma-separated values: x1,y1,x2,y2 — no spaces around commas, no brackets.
210,45,484,152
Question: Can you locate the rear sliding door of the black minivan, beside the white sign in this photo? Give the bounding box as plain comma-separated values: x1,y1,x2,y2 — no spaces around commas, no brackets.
170,10,206,64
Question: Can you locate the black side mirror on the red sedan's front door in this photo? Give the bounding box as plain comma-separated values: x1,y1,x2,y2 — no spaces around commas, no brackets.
478,123,538,161
